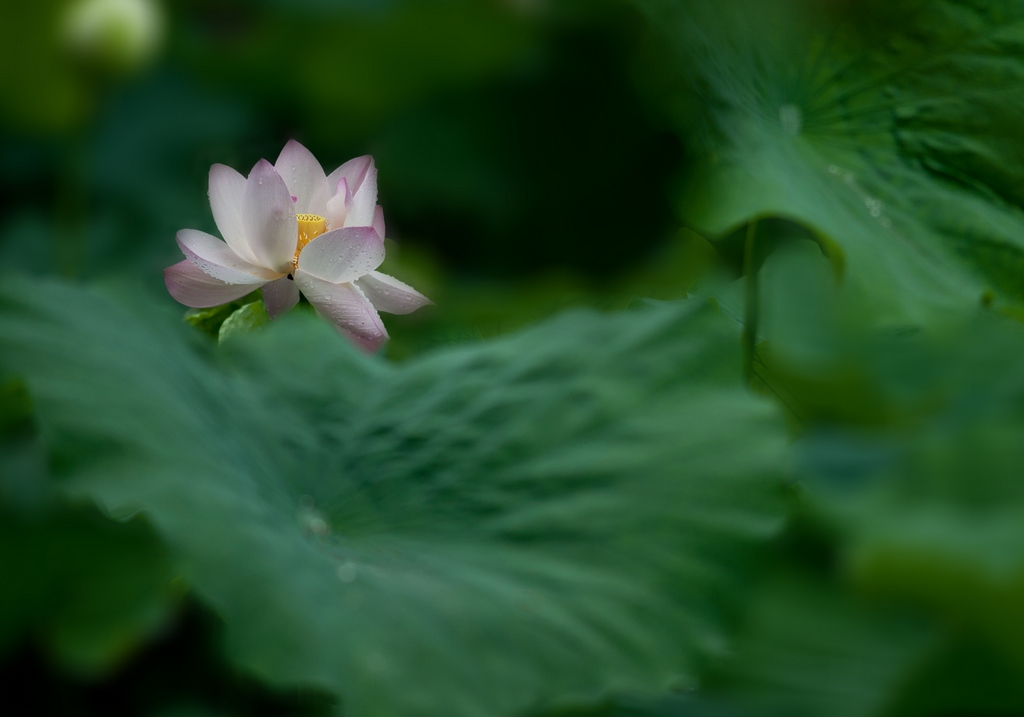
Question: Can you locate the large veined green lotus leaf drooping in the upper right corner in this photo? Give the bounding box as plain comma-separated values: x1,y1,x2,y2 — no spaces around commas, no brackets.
638,0,1024,323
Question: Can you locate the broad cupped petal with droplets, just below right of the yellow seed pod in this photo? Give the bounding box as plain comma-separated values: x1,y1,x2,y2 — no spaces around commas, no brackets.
298,226,384,284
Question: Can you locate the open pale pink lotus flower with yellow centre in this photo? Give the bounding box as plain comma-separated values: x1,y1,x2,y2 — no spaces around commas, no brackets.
164,140,430,351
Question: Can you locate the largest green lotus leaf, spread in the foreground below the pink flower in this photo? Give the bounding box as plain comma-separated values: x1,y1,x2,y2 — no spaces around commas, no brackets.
0,282,785,717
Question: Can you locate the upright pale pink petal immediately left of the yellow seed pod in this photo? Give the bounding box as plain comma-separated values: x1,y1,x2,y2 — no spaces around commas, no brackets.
242,160,299,273
